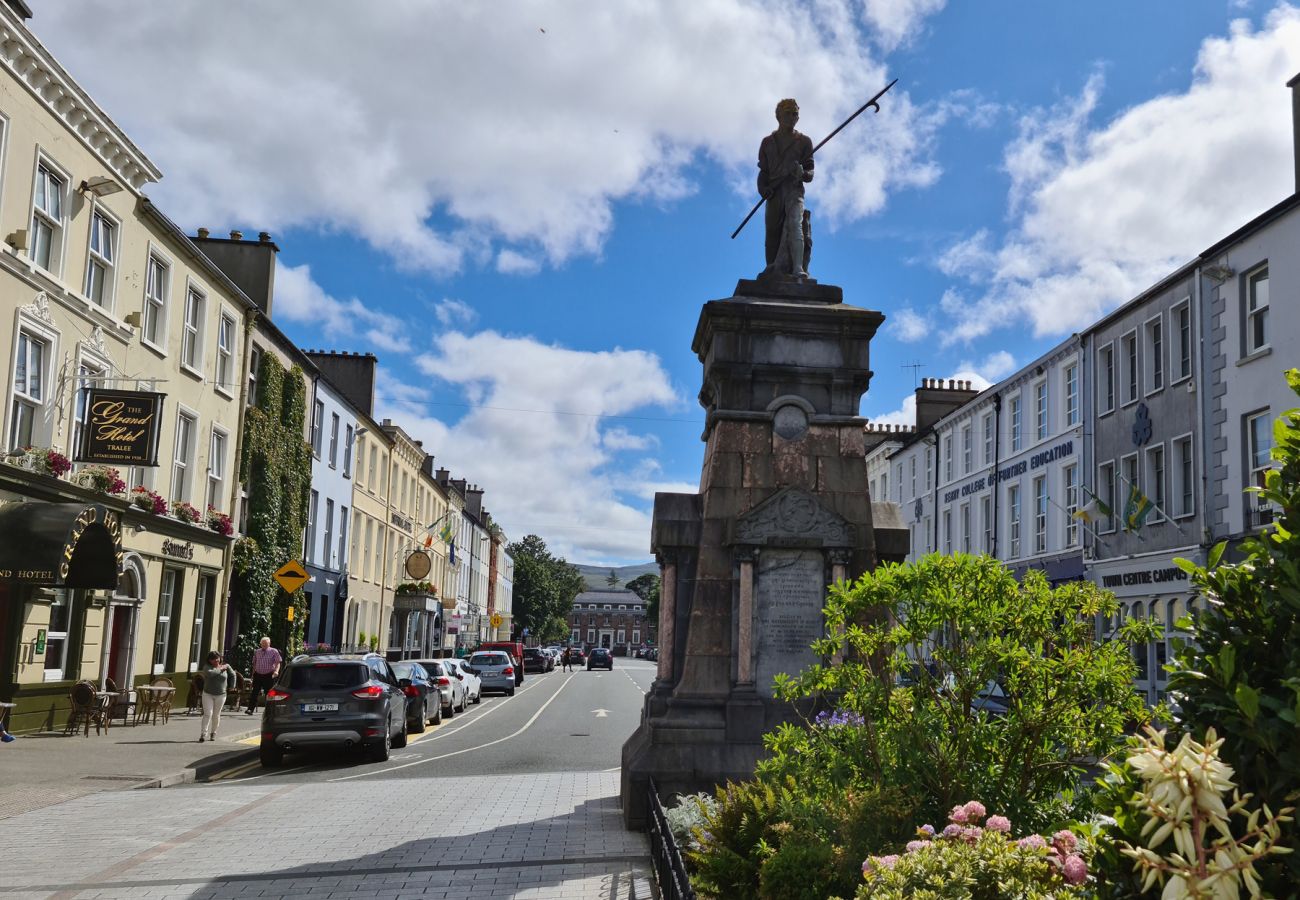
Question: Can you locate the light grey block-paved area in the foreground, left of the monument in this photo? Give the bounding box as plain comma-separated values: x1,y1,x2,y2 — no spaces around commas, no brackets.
0,773,657,900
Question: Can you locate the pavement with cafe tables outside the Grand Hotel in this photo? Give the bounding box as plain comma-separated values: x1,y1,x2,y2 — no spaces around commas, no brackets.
0,709,261,819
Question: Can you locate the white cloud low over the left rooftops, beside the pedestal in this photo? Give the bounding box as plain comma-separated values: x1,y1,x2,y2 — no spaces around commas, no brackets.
376,332,684,562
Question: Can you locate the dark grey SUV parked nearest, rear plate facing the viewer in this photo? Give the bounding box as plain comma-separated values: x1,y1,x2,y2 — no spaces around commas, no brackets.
259,653,407,766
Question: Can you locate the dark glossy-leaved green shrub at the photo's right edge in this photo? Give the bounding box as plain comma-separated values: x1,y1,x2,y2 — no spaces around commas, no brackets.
1169,369,1300,896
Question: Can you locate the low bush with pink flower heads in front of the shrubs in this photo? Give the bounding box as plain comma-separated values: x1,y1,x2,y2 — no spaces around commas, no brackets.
858,800,1088,900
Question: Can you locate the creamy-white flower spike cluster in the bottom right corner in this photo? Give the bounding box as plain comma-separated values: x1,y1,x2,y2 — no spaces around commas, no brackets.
1121,728,1292,900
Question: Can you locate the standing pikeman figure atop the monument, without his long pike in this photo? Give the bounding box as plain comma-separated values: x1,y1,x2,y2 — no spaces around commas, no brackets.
758,99,813,278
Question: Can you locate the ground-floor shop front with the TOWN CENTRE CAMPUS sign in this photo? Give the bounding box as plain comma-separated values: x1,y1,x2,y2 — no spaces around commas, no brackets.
1088,546,1205,705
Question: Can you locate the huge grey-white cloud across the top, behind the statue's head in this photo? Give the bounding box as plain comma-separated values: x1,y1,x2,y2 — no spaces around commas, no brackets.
34,0,943,273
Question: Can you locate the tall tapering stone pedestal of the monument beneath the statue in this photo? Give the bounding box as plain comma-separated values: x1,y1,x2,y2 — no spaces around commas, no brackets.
623,280,906,827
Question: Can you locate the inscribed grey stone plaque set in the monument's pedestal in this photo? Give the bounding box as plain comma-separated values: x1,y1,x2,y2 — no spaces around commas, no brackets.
754,549,826,697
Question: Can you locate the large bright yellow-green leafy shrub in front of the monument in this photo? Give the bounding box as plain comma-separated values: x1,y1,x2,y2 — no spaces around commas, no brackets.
759,554,1157,828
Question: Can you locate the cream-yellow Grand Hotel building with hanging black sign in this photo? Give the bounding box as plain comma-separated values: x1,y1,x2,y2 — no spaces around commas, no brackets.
0,4,252,731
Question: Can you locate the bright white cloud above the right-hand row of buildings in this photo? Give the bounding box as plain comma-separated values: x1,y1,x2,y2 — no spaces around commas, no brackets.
939,5,1300,345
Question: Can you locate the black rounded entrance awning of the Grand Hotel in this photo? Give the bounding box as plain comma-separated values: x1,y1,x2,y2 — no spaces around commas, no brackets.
0,501,122,590
